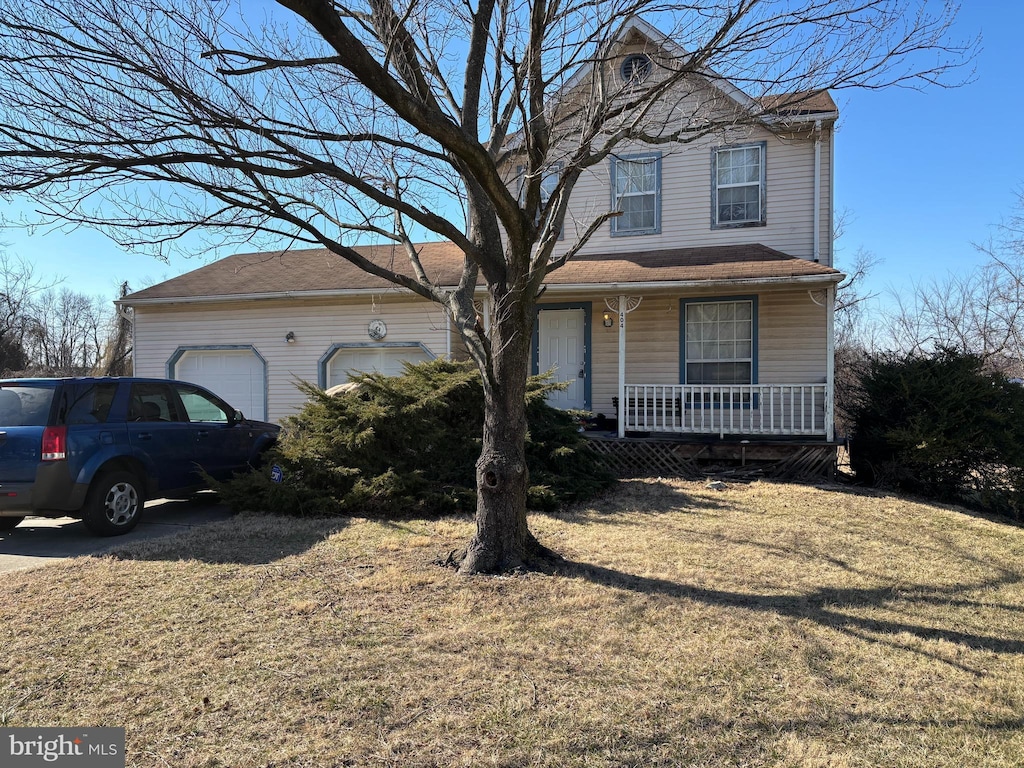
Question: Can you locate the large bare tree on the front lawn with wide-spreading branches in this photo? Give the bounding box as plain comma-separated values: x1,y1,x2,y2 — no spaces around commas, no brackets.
0,0,975,572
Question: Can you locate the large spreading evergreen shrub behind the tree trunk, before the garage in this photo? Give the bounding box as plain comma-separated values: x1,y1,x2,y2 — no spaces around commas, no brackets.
217,360,613,517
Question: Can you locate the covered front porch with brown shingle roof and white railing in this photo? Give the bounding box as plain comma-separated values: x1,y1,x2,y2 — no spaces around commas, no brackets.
531,245,843,450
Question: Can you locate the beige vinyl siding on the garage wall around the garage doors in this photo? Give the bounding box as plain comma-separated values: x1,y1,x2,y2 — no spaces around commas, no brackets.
135,294,451,428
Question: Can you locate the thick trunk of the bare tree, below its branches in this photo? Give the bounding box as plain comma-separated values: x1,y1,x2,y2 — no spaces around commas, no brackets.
460,286,541,573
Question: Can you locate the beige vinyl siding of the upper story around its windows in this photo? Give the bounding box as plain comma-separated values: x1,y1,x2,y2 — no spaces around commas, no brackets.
555,123,831,263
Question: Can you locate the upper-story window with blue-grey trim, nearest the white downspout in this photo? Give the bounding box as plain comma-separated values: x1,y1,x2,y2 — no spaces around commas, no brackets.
711,141,767,227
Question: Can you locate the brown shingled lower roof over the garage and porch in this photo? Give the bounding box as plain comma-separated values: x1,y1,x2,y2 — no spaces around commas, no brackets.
119,242,843,306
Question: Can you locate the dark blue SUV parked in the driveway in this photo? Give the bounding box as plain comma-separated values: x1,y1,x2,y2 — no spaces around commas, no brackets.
0,378,280,536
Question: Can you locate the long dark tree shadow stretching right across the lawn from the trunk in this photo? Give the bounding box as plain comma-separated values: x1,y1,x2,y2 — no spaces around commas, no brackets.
553,560,1024,674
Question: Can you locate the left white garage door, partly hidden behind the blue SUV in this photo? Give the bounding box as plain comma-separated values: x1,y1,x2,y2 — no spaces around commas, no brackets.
174,349,266,420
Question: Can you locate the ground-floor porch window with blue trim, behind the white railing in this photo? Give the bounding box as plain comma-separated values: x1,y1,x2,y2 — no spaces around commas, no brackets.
682,297,757,408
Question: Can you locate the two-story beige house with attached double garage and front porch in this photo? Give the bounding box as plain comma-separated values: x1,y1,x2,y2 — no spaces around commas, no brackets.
122,22,842,473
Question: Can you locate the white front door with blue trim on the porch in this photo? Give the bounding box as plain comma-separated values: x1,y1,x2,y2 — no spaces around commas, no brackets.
538,309,587,410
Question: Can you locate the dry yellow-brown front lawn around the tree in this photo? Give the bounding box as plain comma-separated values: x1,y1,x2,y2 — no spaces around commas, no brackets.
0,479,1024,768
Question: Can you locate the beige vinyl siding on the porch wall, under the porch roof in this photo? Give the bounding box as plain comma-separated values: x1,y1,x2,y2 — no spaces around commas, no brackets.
540,289,826,418
